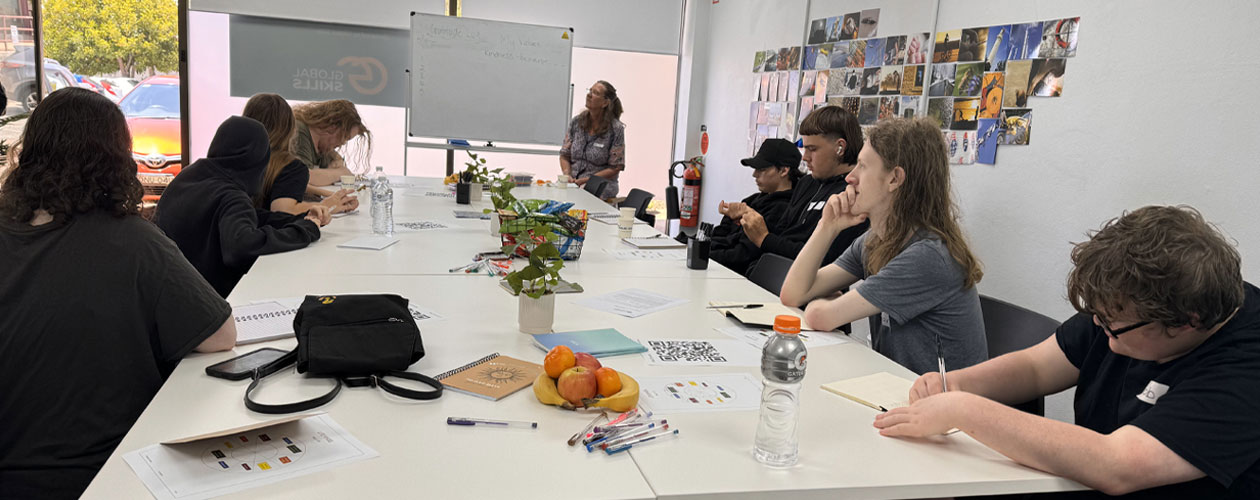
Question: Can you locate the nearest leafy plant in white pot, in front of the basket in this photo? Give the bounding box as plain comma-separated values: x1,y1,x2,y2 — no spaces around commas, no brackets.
503,223,577,334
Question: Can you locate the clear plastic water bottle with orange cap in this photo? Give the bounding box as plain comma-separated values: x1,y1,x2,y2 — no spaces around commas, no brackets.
752,315,805,467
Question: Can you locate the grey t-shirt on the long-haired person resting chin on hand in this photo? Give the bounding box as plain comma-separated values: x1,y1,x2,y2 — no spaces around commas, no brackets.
835,232,989,374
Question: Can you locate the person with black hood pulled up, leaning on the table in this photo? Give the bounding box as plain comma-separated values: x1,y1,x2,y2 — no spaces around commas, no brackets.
154,116,330,298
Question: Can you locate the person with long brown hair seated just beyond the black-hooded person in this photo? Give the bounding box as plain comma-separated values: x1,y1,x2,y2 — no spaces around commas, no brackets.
241,93,359,214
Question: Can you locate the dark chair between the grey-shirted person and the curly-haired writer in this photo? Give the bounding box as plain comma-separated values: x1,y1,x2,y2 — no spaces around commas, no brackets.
980,295,1060,416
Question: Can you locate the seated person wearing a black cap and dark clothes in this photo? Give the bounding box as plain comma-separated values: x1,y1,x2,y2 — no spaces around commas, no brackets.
705,139,804,273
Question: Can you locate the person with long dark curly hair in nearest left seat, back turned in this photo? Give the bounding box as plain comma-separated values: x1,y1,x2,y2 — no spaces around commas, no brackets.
0,87,236,499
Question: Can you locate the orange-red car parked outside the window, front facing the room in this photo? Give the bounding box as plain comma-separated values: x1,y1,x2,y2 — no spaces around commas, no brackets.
118,76,184,202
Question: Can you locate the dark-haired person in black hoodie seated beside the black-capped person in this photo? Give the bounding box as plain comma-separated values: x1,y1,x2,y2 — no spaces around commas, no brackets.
732,106,868,275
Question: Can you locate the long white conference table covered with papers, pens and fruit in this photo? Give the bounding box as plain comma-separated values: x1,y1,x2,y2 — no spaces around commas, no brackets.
84,178,1084,500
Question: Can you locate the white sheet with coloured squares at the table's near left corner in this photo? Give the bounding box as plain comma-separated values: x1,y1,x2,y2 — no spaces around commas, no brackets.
122,414,378,500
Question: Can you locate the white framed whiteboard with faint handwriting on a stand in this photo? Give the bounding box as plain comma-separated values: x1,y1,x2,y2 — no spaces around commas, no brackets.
407,13,573,146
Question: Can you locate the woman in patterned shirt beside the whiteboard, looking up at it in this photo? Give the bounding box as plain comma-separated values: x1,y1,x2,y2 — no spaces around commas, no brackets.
559,79,626,199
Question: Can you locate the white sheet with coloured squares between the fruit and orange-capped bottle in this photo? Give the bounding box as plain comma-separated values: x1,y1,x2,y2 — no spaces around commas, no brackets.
638,373,761,414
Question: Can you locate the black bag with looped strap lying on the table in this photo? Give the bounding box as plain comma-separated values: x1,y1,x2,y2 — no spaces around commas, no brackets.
244,295,442,413
